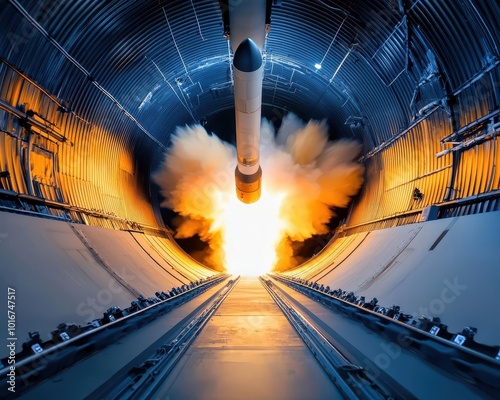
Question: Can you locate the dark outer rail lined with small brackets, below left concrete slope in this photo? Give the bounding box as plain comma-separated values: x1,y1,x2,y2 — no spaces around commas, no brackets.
0,275,228,395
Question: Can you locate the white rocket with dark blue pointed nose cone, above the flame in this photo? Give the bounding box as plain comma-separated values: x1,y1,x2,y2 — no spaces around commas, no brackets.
233,38,263,204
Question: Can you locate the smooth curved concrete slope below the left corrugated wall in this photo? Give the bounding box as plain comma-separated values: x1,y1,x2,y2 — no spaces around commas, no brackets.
0,212,213,357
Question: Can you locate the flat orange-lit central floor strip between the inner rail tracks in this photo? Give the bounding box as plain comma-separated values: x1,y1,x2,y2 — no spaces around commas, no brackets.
155,278,341,400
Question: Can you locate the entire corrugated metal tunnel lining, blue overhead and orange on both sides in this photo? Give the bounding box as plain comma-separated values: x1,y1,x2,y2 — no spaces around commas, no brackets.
0,0,500,239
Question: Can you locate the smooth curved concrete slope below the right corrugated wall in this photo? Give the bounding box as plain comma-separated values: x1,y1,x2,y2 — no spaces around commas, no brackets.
290,212,500,345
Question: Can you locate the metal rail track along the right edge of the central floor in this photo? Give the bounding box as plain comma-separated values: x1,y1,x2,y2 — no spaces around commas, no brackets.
260,277,406,399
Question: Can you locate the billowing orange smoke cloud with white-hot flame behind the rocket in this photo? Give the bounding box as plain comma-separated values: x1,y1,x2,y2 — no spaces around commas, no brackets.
155,114,364,275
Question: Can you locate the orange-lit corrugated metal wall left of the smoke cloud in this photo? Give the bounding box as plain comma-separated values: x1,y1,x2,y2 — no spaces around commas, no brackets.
0,63,156,227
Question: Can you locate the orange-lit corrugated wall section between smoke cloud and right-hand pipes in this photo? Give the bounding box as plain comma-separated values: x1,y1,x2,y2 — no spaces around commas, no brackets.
349,110,453,226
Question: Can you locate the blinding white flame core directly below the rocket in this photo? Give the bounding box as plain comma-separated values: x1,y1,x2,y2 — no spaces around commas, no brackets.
212,188,285,276
